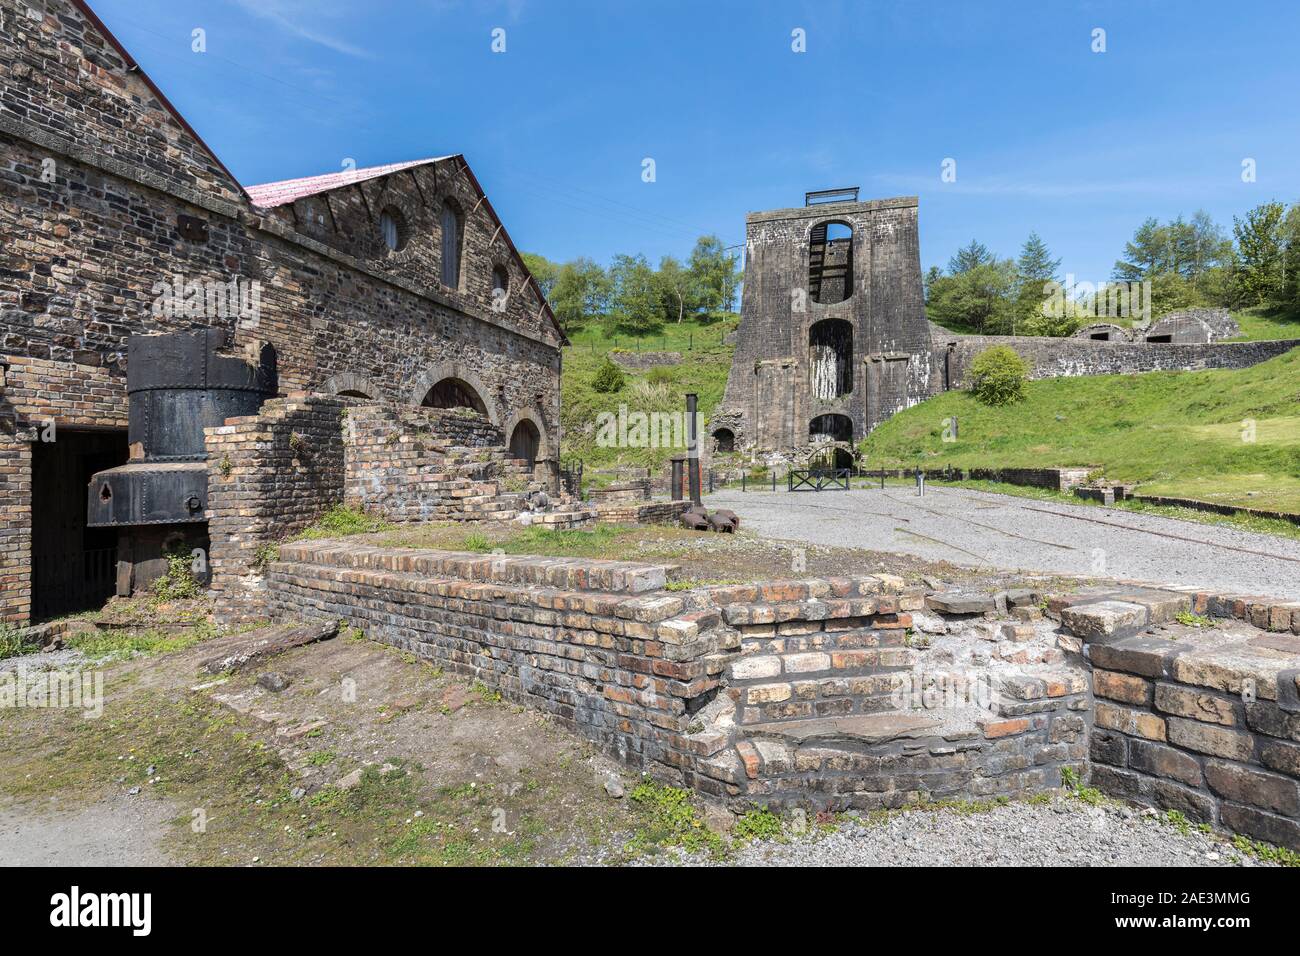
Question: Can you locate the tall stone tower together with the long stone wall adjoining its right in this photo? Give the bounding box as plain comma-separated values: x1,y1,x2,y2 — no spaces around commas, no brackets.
707,187,1300,467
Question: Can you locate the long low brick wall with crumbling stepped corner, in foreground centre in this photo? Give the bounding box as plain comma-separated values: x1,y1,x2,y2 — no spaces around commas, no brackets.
268,541,1089,809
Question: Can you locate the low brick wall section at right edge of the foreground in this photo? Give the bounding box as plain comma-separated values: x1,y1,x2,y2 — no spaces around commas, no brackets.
1061,589,1300,849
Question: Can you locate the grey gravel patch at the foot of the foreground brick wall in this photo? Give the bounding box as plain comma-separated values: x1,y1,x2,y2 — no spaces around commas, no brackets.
637,797,1271,866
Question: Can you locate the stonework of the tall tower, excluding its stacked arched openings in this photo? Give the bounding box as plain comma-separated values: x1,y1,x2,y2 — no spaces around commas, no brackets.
715,198,930,451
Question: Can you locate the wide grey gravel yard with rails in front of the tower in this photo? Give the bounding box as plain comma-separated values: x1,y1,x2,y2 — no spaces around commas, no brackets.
706,488,1300,598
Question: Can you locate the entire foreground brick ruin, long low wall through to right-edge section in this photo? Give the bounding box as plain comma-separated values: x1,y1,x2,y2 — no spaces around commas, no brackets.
256,541,1300,848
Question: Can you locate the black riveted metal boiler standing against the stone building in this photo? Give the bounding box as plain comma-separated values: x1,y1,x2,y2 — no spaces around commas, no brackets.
86,329,276,594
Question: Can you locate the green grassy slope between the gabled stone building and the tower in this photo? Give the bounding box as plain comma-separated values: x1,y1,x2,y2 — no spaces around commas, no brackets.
560,316,740,468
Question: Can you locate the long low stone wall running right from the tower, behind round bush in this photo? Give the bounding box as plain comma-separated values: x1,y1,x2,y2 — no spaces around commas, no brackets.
933,336,1300,390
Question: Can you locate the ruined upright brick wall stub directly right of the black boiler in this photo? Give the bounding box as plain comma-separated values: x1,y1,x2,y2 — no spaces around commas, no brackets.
204,397,347,620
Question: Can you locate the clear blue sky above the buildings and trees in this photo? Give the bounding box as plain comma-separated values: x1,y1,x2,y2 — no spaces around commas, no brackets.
91,0,1300,281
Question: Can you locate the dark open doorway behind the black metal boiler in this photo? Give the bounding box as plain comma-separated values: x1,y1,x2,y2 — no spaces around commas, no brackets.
31,428,127,622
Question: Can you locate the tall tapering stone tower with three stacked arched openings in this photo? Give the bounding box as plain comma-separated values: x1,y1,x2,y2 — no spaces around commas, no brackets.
709,187,931,464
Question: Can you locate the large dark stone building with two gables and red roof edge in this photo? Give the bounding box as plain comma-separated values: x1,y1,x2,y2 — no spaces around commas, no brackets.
0,0,564,623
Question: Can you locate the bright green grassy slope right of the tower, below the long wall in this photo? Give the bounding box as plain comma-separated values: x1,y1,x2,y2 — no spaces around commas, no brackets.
863,349,1300,511
